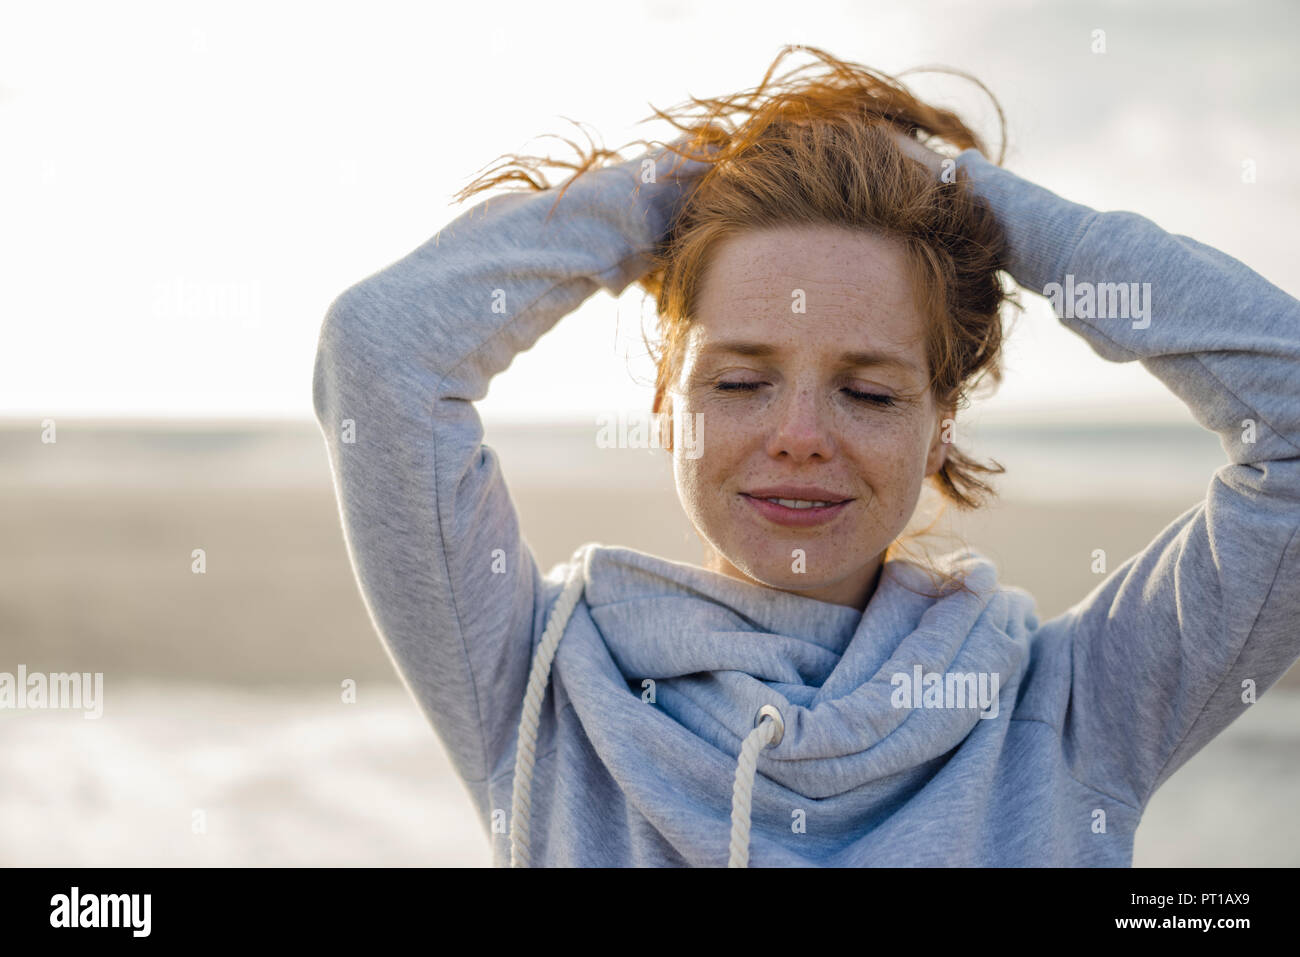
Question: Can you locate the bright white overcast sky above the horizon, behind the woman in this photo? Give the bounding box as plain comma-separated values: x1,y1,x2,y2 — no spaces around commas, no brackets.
0,0,1300,421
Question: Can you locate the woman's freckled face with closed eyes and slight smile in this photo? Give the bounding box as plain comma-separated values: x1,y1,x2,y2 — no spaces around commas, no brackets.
668,226,953,609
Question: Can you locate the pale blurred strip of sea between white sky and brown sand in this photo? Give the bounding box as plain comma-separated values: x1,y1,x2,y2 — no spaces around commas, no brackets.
0,410,1227,505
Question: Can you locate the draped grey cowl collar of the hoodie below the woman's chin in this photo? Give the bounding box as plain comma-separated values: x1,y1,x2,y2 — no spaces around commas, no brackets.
555,546,1036,798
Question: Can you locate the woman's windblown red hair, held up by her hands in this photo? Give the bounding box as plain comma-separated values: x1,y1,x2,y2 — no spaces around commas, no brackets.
458,46,1019,595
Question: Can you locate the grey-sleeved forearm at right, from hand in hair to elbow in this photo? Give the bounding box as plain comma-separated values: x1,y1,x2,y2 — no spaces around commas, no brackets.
957,150,1300,463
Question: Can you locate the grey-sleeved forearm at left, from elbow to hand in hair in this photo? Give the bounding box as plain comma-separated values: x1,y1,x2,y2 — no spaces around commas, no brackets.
314,138,698,408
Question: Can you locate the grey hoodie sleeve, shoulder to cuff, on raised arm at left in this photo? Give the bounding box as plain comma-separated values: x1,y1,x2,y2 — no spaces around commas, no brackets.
313,140,702,811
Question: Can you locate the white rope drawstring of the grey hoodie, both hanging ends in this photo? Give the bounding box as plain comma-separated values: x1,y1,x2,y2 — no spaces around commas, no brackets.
510,547,785,867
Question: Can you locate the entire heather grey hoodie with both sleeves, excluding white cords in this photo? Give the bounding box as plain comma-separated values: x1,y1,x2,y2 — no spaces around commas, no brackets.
313,141,1300,867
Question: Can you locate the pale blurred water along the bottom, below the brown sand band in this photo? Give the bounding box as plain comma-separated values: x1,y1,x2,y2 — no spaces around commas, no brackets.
0,684,1300,867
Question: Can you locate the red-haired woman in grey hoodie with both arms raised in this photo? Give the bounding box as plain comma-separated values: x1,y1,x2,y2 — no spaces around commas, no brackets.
315,48,1300,866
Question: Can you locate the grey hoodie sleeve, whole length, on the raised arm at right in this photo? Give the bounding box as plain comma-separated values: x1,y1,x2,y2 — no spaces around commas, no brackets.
958,150,1300,809
